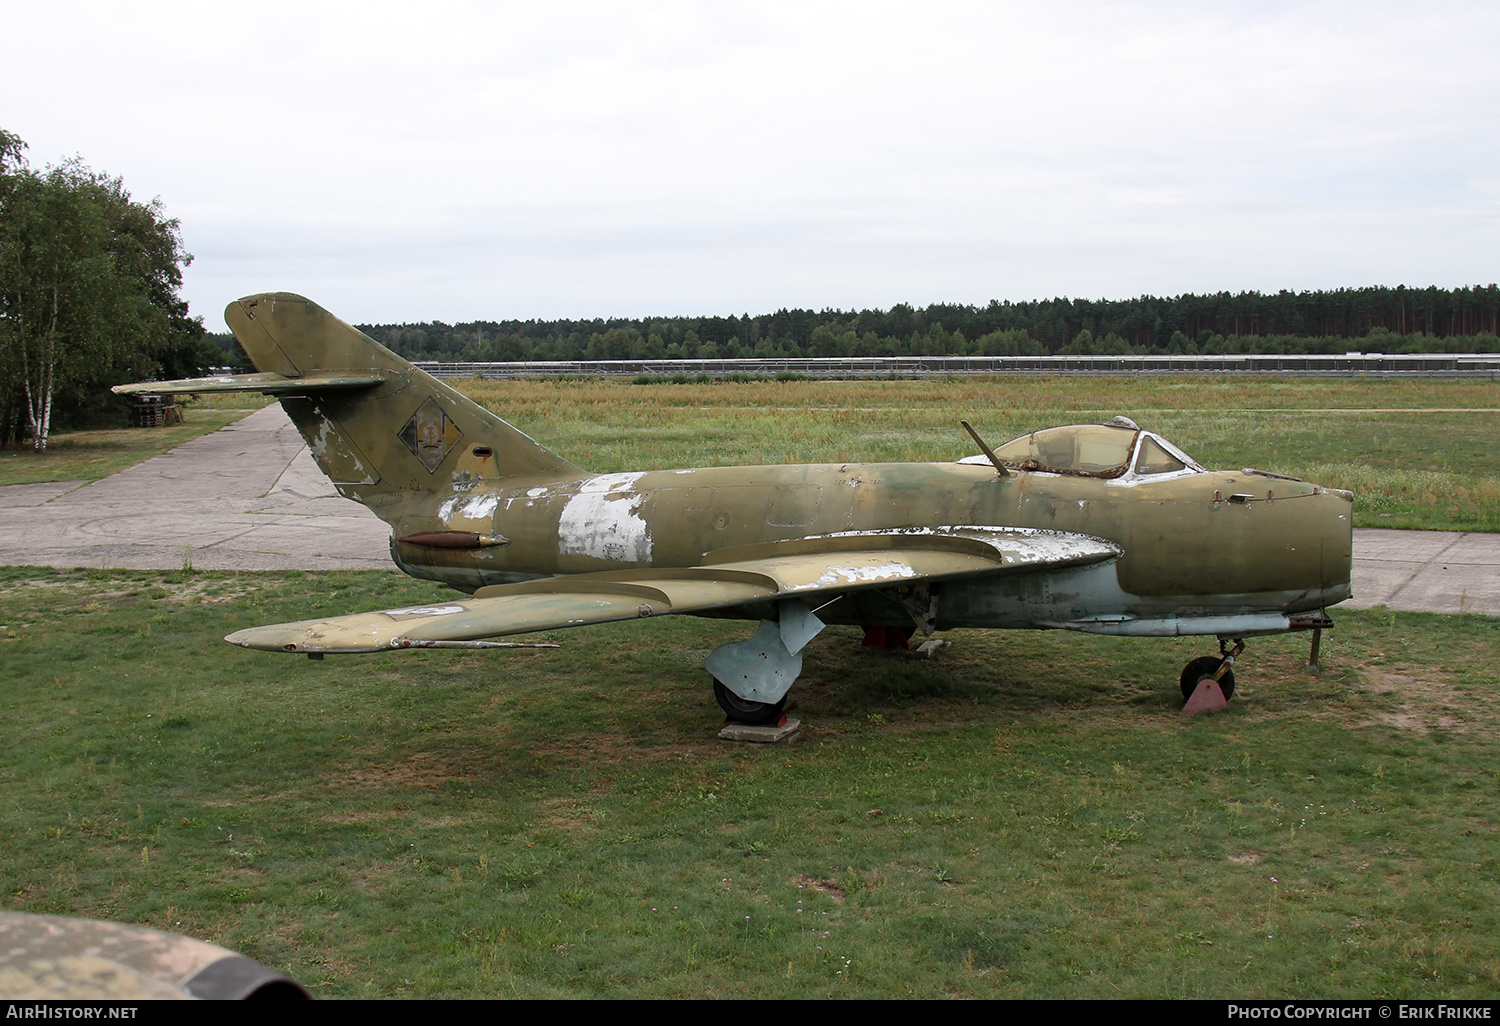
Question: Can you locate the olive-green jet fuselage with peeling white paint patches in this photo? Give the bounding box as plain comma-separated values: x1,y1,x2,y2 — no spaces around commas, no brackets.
381,455,1352,633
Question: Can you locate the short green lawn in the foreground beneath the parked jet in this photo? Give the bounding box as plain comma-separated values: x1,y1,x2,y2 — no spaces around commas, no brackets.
0,569,1500,999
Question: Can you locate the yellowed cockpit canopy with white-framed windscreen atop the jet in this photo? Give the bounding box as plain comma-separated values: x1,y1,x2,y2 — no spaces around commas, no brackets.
960,417,1203,479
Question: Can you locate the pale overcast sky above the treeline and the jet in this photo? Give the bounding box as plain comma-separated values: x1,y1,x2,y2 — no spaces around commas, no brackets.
0,0,1500,330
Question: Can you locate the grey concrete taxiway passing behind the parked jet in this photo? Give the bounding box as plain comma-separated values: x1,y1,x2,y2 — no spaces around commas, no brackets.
0,405,1500,617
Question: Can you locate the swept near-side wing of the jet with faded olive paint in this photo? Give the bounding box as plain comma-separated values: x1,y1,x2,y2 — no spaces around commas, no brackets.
225,528,1121,654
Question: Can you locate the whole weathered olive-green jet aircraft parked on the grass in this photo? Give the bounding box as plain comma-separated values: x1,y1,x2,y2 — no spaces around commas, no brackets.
116,293,1353,725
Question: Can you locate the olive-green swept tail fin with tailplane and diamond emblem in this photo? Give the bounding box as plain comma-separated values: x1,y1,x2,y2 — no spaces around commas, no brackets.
116,293,584,507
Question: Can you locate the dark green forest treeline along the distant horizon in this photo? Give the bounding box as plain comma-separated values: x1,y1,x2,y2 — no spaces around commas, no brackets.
208,285,1500,369
